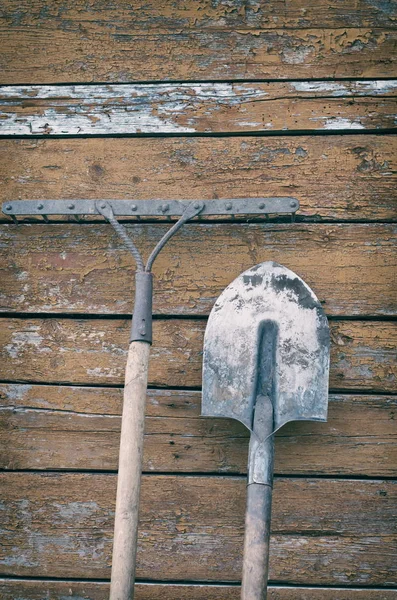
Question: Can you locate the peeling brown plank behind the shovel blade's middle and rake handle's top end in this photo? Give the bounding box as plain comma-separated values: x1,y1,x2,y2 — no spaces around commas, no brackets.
0,318,397,392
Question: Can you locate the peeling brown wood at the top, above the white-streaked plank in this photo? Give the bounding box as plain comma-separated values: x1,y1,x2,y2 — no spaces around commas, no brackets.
0,0,396,84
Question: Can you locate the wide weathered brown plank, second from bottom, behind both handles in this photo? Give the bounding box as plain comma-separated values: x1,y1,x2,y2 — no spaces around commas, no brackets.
0,473,397,587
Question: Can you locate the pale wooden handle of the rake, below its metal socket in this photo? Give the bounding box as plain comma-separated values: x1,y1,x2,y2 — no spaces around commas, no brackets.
110,341,150,600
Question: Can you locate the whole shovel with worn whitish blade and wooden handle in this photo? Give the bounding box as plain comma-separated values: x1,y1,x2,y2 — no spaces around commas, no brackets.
202,262,330,600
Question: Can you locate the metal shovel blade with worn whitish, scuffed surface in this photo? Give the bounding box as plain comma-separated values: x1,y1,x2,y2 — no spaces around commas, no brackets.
202,262,330,431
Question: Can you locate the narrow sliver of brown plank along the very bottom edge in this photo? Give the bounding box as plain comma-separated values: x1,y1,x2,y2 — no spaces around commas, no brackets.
0,579,397,600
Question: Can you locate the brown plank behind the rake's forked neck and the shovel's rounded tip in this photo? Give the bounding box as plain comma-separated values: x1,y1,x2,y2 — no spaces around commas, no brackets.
0,223,397,316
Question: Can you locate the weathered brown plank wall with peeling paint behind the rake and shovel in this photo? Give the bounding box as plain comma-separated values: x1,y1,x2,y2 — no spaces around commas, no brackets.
0,0,397,600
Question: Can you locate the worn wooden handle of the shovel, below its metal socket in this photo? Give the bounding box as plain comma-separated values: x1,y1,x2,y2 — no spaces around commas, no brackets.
241,483,272,600
